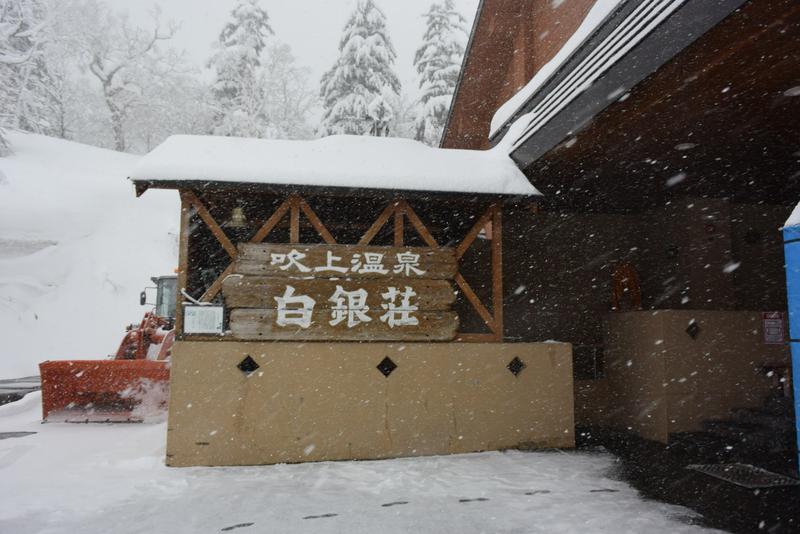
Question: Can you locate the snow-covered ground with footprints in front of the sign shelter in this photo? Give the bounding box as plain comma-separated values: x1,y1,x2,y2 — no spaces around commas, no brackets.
0,393,720,534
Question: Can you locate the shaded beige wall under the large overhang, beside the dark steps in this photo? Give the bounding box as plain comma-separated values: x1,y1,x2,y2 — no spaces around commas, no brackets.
577,310,789,443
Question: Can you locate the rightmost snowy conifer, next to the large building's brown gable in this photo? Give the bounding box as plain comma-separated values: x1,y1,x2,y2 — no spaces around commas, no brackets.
414,0,467,145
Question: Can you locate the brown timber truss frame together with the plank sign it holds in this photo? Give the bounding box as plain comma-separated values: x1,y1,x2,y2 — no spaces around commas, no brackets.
176,190,503,342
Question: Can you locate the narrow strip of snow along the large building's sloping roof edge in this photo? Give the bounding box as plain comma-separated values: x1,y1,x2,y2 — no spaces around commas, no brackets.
490,0,624,136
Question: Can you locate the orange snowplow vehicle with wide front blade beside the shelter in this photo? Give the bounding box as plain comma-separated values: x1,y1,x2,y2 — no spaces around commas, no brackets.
39,276,177,423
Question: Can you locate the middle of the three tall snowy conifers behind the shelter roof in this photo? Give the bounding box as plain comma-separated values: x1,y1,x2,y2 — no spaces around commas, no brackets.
319,0,400,135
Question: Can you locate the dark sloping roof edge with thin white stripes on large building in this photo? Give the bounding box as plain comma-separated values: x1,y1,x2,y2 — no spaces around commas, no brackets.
490,0,747,169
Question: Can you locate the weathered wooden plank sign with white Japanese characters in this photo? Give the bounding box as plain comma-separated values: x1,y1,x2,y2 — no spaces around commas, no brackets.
222,243,458,341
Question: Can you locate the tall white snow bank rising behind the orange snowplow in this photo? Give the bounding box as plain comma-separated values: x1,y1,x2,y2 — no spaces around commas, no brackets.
0,134,180,378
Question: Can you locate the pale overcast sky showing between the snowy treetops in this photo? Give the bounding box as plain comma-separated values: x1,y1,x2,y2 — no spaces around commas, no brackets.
106,0,478,96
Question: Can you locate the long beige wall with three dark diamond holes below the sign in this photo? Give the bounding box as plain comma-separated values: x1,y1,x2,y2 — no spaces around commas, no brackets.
167,341,574,466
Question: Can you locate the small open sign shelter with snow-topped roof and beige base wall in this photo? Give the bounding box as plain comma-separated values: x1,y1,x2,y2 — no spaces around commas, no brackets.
130,136,574,466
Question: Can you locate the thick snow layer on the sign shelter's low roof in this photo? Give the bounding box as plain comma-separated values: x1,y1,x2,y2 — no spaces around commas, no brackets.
130,135,540,195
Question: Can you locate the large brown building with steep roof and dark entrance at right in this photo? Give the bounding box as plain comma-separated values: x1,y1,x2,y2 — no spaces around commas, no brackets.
441,0,800,454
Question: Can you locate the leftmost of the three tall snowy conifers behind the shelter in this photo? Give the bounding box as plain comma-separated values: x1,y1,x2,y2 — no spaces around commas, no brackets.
209,0,273,137
